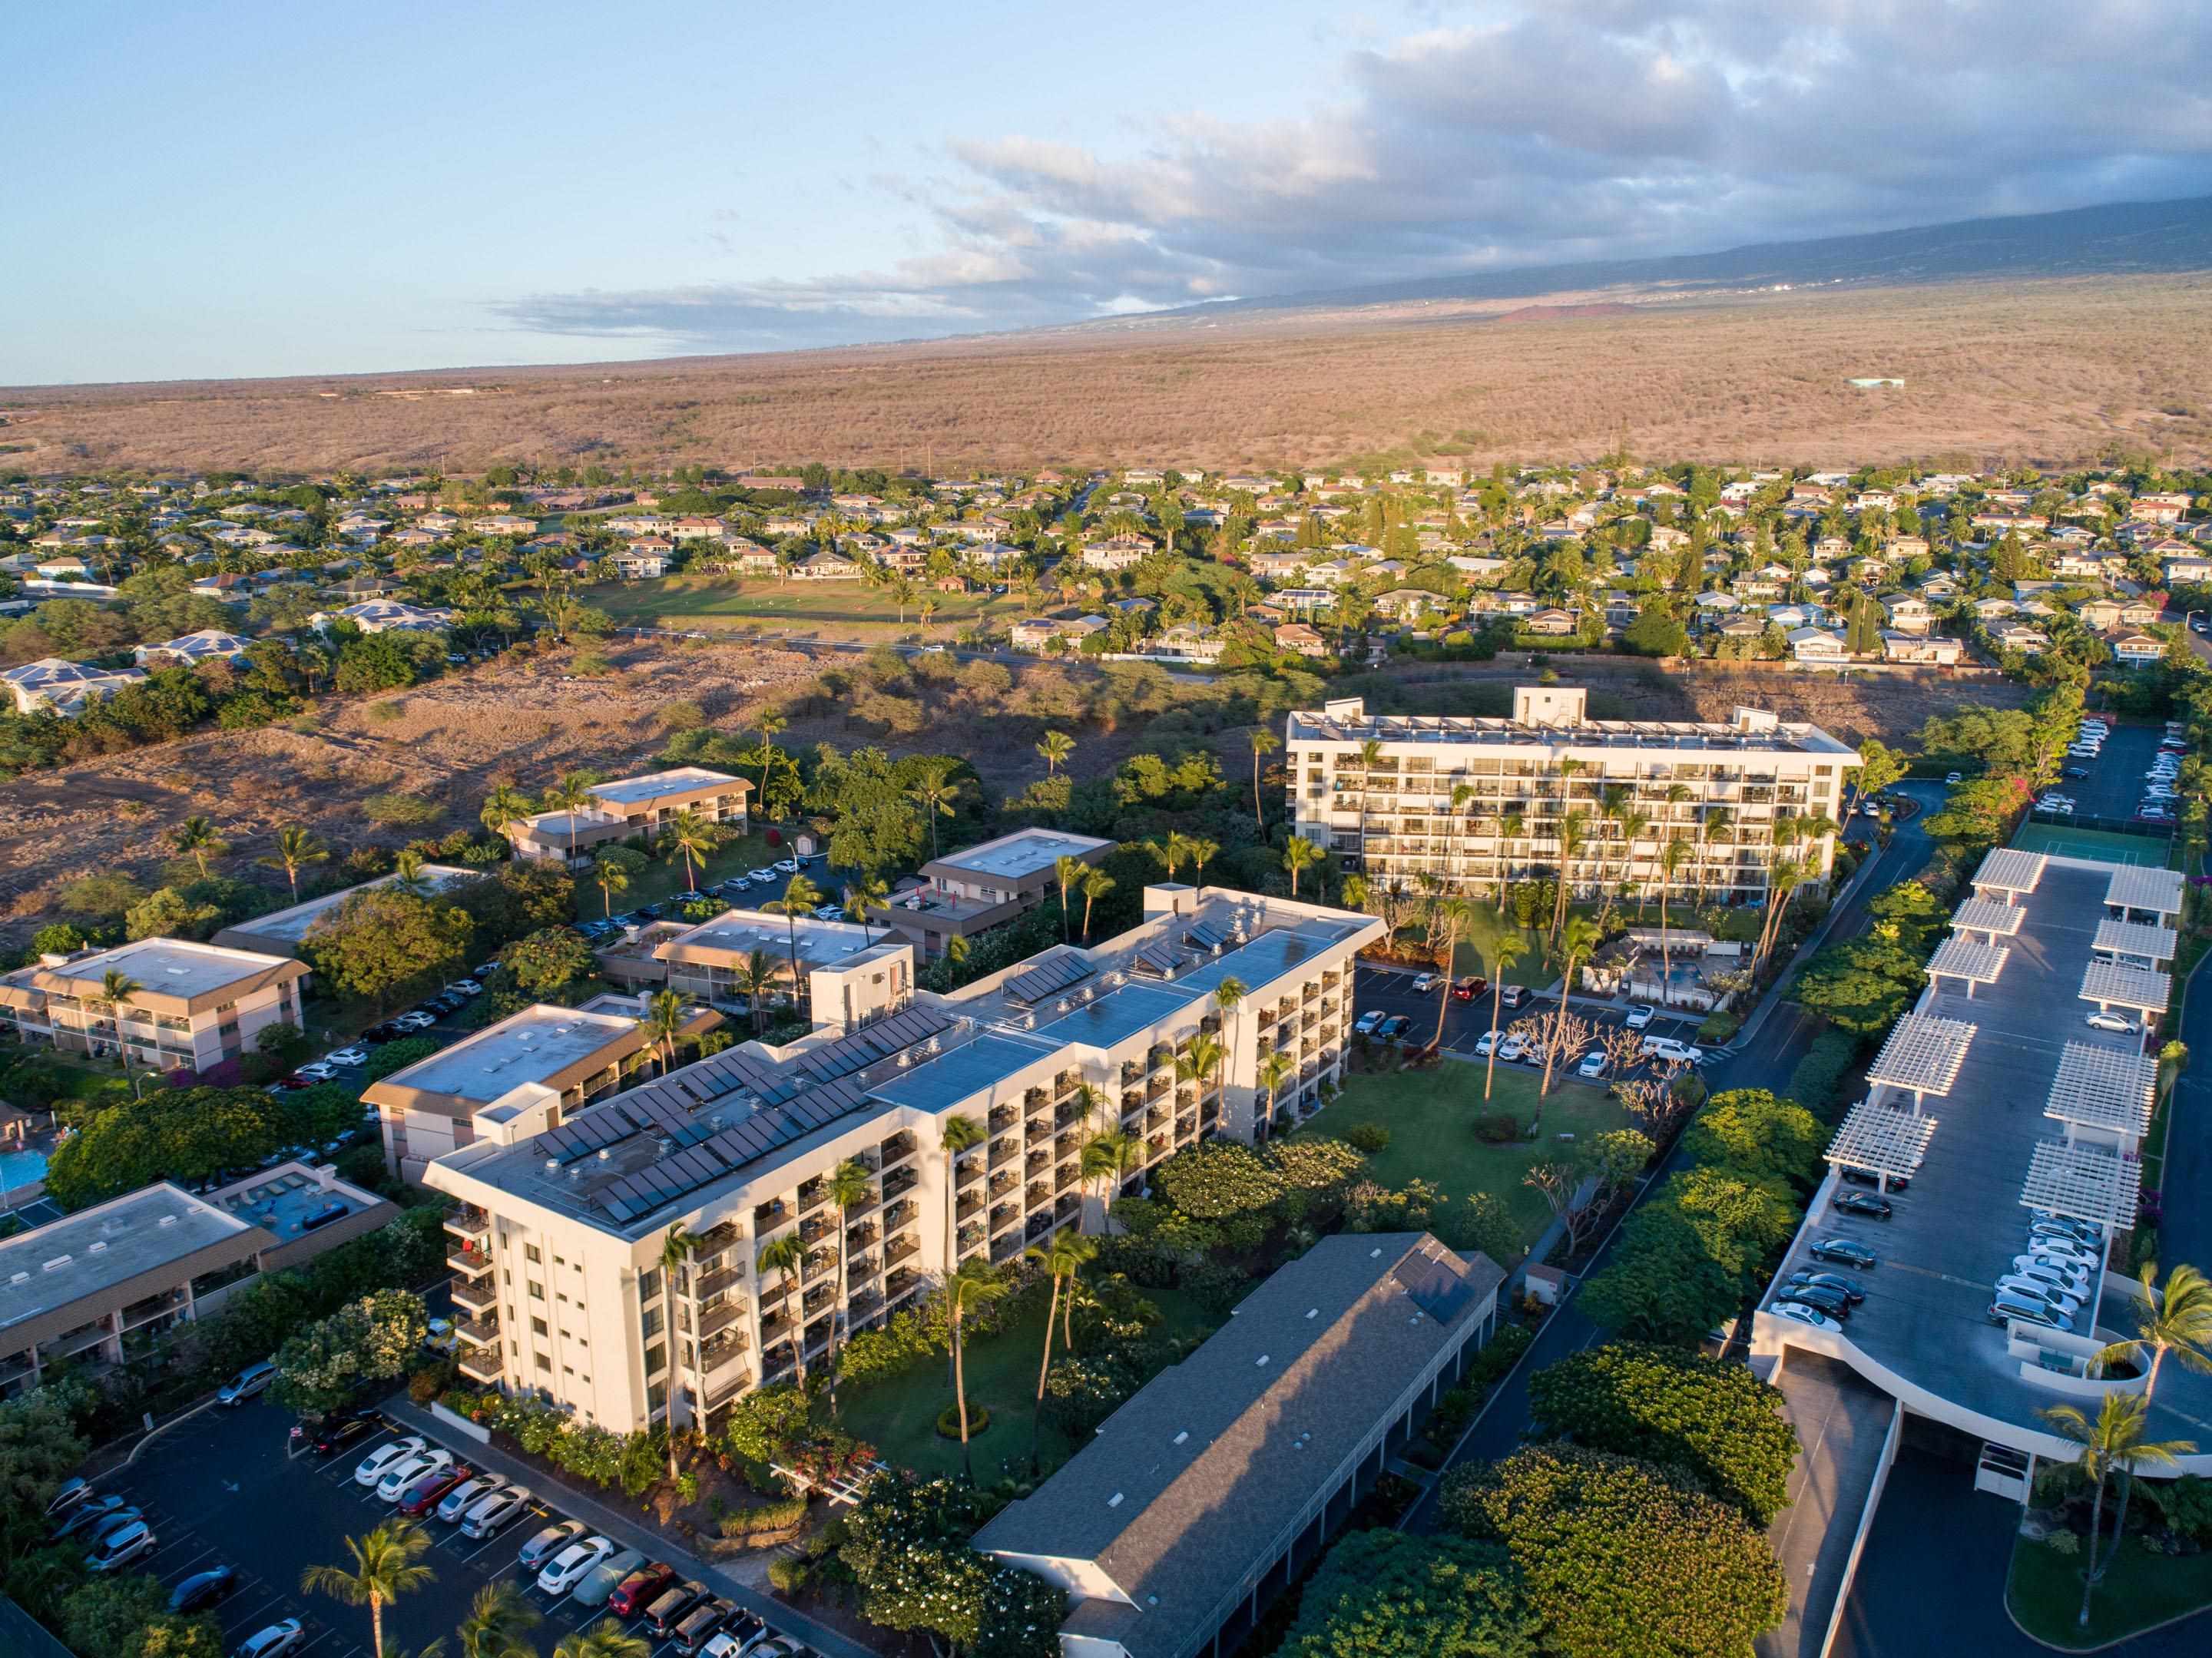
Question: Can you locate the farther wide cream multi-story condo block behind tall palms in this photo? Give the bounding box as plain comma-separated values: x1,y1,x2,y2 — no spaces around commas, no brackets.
1283,685,1858,902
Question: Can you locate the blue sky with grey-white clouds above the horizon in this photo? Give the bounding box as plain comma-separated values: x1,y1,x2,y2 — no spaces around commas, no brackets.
0,0,2212,385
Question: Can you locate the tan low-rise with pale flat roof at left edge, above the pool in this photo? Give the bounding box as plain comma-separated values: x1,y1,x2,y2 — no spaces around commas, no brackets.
0,938,307,1070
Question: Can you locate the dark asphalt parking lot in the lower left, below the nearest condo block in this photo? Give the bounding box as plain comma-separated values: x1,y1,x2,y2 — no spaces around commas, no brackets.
100,1402,836,1658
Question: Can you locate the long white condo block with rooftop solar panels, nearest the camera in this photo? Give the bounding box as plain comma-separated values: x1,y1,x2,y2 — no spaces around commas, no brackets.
425,884,1382,1430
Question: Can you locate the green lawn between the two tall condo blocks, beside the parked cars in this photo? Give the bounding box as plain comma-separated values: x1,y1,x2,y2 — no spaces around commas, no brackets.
1307,1059,1632,1265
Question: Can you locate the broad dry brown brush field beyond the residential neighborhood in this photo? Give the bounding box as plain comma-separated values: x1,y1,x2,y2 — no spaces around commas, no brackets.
0,274,2212,471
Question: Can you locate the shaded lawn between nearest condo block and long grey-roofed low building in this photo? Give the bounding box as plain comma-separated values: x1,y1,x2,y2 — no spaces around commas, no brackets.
840,1289,1221,1484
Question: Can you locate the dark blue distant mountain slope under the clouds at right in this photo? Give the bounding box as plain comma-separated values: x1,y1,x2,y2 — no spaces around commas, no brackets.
1154,197,2212,316
